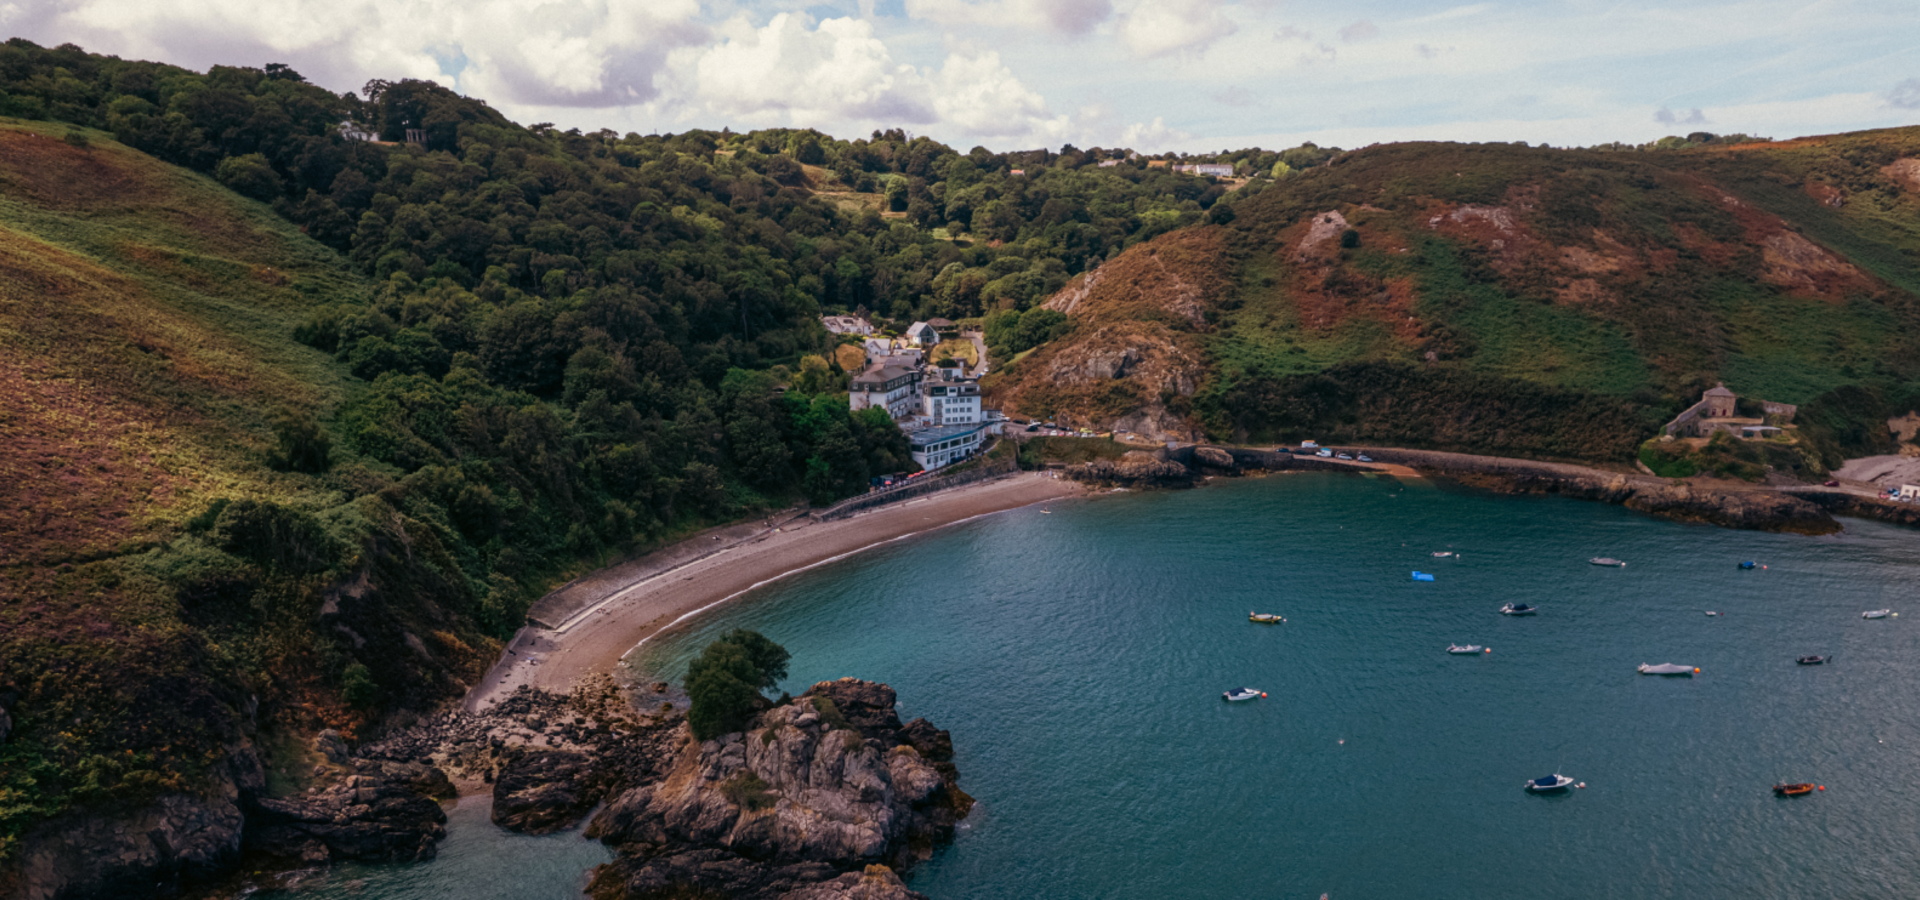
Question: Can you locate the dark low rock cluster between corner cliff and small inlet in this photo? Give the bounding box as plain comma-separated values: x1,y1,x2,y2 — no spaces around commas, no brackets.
246,760,453,864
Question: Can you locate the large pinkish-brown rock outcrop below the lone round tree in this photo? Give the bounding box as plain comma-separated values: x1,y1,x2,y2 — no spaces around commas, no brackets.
588,679,972,900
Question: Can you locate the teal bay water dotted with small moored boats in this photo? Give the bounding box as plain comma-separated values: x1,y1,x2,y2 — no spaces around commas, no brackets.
629,476,1920,900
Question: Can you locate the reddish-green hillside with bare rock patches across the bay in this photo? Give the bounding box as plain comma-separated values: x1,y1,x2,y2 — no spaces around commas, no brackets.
995,129,1920,461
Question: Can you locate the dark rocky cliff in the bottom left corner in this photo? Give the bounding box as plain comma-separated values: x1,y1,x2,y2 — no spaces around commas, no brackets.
0,745,267,900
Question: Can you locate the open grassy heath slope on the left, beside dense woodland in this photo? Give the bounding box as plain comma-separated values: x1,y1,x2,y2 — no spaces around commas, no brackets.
0,121,389,852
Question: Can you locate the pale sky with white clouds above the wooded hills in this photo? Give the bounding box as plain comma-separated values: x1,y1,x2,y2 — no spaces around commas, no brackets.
0,0,1920,152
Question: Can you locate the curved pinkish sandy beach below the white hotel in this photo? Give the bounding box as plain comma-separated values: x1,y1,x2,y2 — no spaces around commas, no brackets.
467,472,1085,712
